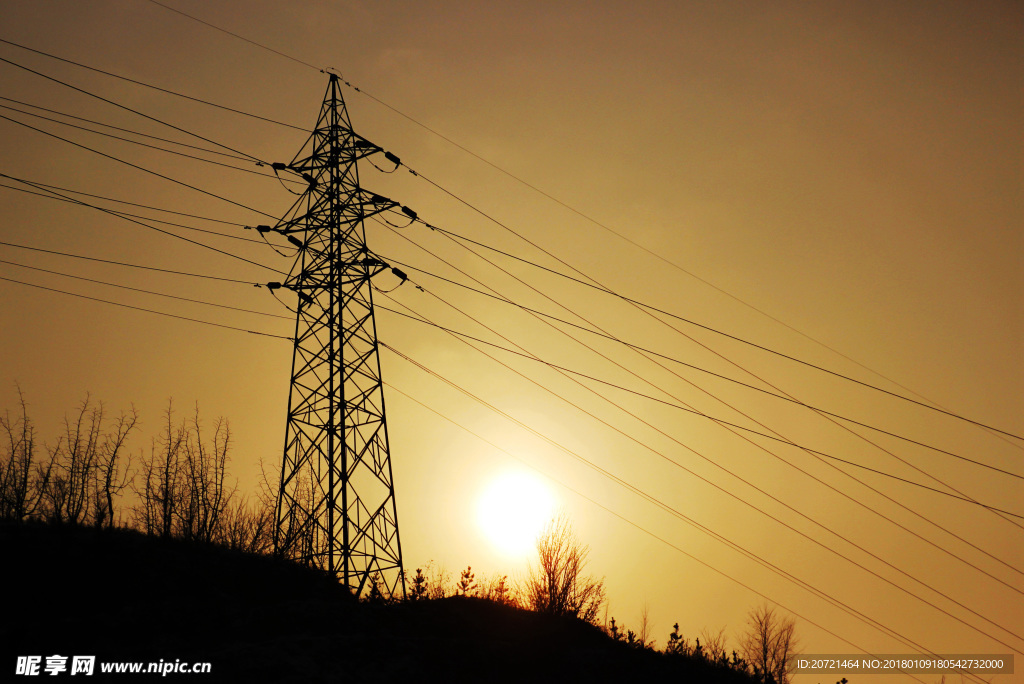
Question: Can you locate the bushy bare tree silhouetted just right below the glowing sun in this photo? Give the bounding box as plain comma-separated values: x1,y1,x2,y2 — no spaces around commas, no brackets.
523,514,604,624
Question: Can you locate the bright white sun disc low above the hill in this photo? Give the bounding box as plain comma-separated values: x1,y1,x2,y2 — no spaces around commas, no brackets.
477,472,555,557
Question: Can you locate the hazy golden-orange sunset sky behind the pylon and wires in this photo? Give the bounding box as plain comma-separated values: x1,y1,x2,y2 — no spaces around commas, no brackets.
0,0,1024,683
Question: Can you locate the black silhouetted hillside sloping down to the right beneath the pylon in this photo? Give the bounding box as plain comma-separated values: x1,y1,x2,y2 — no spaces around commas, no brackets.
0,523,753,682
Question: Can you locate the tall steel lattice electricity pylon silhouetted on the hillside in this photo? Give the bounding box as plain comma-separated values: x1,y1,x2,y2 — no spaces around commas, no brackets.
273,75,406,596
